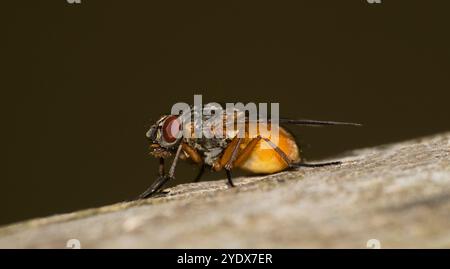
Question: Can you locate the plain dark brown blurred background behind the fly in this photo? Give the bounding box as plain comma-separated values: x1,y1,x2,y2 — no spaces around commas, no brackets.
0,0,450,224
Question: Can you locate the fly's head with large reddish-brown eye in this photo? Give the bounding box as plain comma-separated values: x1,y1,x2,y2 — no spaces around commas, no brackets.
146,115,182,158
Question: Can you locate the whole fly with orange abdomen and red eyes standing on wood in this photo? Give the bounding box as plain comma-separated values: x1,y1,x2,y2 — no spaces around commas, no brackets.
137,105,360,199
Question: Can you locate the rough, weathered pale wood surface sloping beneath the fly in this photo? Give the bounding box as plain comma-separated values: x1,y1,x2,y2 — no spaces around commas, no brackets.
0,133,450,248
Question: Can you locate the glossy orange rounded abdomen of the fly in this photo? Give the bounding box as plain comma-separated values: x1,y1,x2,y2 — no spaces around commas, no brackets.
235,127,300,174
